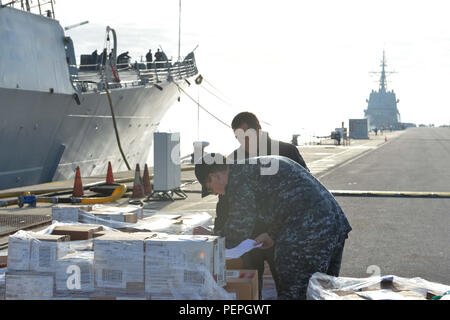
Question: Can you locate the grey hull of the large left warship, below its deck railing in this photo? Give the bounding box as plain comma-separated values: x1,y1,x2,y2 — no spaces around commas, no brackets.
0,81,187,189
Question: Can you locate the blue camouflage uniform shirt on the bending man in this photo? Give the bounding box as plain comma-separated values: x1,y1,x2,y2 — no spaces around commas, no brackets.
214,156,351,248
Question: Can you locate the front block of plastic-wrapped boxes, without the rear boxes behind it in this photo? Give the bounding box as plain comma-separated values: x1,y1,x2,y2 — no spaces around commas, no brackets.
5,229,230,299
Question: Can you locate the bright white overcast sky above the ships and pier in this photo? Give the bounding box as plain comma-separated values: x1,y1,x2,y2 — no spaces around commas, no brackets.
55,0,450,153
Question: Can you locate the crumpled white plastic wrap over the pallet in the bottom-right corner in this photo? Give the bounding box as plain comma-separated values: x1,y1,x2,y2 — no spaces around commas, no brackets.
306,272,450,300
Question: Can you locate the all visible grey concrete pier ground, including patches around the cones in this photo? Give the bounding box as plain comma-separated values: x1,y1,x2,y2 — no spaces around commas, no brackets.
0,128,450,298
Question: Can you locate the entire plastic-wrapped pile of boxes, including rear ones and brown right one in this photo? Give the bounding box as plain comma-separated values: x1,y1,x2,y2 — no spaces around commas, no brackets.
0,205,258,299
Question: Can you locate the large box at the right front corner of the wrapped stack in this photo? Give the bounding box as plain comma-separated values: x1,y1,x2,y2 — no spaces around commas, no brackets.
145,235,225,296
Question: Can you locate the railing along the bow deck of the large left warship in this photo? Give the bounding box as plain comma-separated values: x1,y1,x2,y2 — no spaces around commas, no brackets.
70,59,198,92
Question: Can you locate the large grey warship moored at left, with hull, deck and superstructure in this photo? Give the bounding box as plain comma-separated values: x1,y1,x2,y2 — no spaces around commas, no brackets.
0,0,198,189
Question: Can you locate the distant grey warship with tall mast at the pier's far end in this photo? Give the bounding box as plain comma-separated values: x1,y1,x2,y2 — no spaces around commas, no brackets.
364,51,403,130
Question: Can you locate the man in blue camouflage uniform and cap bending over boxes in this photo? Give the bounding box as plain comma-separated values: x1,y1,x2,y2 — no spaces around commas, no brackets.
195,156,351,299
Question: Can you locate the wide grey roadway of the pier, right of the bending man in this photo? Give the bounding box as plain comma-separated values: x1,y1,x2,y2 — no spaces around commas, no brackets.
321,128,450,285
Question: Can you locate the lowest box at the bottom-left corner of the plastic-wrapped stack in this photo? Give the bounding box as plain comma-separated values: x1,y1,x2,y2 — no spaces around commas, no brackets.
6,272,54,300
